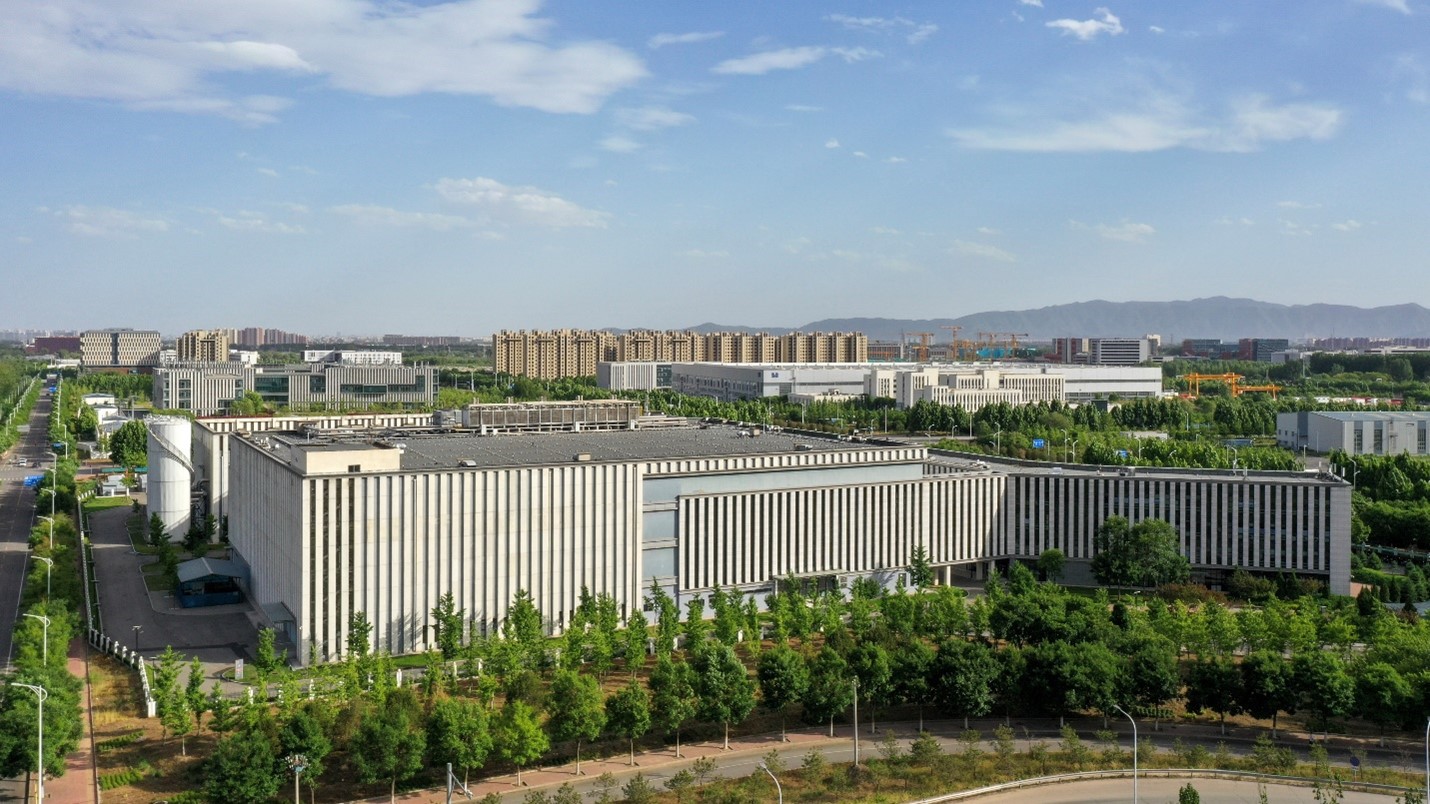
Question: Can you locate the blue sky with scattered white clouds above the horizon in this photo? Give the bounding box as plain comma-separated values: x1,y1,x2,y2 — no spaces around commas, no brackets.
0,0,1430,335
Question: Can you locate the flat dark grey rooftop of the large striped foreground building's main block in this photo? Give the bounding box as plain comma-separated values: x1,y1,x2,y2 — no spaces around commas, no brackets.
253,425,888,471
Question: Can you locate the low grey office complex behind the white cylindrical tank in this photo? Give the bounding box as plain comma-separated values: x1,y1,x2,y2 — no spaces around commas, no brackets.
153,362,436,416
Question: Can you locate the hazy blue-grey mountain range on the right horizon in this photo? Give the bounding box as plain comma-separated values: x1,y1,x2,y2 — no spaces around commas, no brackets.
691,296,1430,343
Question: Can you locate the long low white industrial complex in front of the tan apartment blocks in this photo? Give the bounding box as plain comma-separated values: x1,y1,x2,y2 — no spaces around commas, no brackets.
596,363,1163,411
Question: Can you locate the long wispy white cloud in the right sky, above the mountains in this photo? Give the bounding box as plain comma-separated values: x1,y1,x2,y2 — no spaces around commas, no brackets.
947,92,1343,153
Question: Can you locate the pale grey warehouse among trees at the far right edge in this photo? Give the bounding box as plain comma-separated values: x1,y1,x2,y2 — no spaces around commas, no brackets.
1276,411,1430,455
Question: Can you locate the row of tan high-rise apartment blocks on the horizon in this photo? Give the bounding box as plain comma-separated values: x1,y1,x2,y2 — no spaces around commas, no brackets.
492,329,868,379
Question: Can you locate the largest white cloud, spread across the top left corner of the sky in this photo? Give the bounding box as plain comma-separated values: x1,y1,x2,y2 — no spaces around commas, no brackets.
0,0,646,124
